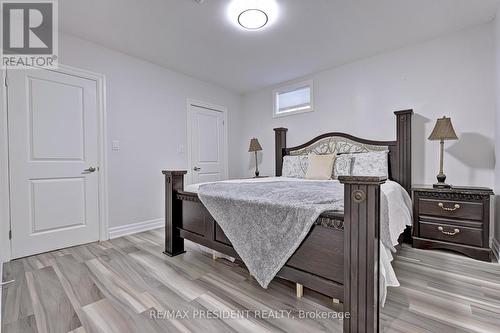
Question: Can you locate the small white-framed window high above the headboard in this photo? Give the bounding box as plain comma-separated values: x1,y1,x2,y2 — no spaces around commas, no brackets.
273,81,313,117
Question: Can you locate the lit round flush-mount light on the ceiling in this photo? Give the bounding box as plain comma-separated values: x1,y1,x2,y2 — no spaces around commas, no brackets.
227,0,278,31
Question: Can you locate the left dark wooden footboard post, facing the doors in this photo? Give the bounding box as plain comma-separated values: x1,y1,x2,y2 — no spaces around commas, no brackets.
162,171,187,257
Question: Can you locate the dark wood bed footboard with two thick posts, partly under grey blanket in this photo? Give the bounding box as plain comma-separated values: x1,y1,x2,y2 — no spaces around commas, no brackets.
163,171,386,333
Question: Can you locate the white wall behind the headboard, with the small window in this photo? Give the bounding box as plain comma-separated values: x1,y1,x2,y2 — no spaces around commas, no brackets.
240,24,495,187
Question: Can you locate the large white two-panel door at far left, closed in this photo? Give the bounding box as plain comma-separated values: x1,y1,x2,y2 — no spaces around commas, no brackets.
7,69,99,258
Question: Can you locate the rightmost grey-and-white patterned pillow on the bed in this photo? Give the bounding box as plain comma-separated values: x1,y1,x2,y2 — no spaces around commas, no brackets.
351,150,389,177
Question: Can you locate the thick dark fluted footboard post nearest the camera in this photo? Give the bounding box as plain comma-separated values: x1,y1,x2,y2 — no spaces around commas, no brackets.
339,176,386,333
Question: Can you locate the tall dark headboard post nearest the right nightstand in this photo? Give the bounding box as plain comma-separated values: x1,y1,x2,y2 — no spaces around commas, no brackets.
394,110,413,192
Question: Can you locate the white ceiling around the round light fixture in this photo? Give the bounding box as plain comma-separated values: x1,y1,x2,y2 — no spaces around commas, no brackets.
59,0,499,93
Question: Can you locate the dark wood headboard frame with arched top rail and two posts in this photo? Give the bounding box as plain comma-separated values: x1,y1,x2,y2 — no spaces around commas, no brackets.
274,110,413,192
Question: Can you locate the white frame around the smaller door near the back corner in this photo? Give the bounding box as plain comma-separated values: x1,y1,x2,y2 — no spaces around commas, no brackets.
186,98,229,184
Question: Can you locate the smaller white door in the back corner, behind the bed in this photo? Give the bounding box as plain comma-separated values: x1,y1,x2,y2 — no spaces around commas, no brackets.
189,103,226,184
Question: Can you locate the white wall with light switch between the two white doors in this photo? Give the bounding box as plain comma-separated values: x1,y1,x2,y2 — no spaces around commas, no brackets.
59,35,241,227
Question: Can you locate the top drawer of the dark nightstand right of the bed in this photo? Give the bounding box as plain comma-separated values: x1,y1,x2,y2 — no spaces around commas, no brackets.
418,199,484,221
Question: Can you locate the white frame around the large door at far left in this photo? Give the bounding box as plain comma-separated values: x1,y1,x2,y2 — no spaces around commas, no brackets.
0,65,109,262
